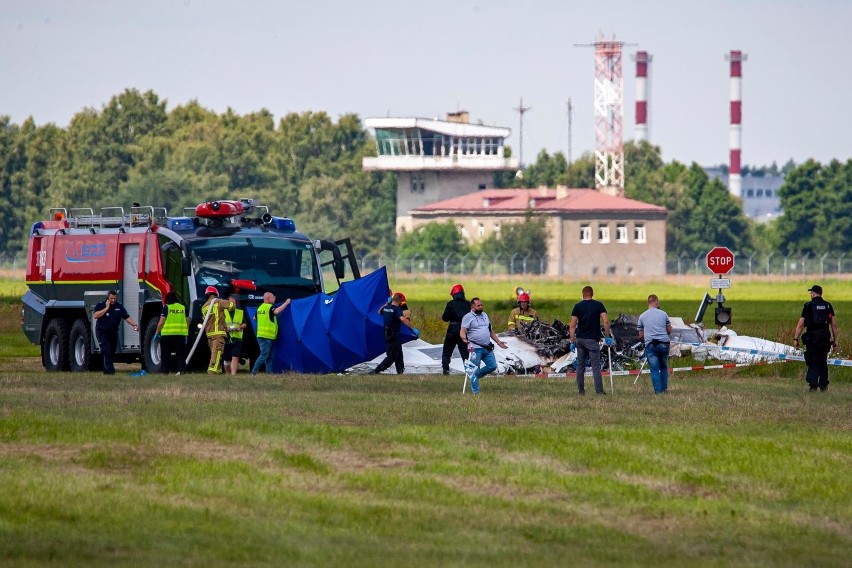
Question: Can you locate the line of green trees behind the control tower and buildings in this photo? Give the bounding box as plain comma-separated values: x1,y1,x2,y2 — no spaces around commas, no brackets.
0,89,852,256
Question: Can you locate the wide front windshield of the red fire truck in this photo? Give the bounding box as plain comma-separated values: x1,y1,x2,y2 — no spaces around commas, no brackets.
190,236,322,296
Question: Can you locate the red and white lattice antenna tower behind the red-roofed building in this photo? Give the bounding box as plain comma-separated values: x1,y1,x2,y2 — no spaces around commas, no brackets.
585,34,624,195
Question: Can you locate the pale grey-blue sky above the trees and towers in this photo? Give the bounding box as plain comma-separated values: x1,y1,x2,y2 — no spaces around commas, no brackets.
0,0,852,166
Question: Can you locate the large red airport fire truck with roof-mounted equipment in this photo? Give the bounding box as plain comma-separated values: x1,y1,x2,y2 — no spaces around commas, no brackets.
22,199,360,372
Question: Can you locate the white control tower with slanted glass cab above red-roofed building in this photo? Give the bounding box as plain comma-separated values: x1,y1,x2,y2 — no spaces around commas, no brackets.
363,111,519,232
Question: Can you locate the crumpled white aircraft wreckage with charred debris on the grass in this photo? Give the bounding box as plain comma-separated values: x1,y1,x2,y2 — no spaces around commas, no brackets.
347,296,802,375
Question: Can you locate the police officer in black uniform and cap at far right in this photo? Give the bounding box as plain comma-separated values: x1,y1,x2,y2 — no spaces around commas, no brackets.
793,284,837,392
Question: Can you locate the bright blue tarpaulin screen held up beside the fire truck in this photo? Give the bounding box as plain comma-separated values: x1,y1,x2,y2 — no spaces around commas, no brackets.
246,267,414,373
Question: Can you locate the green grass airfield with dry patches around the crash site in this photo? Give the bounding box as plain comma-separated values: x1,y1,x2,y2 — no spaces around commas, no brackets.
0,272,852,566
